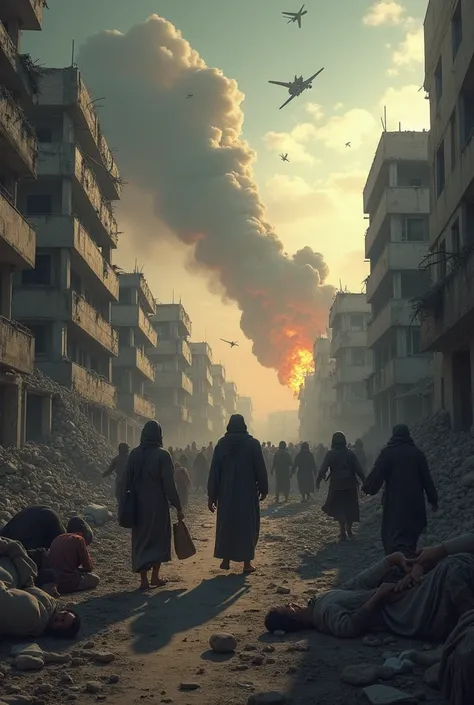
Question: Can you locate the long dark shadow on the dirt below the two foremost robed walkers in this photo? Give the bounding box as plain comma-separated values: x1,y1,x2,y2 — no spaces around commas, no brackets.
76,575,250,654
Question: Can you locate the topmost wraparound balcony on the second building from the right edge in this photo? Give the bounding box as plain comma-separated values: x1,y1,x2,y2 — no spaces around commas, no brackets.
365,187,430,258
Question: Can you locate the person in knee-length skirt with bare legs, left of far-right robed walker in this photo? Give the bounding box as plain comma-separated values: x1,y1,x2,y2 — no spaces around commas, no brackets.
316,431,365,541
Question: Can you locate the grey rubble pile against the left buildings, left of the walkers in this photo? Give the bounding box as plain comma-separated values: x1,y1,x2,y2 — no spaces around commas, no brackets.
0,370,116,525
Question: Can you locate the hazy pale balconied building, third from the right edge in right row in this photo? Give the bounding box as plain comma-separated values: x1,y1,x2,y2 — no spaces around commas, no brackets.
329,292,374,439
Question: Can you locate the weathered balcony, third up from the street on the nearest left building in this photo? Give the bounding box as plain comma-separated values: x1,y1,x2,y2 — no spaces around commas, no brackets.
0,86,38,177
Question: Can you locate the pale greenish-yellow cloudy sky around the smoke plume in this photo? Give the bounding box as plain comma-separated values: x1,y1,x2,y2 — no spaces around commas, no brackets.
23,0,429,426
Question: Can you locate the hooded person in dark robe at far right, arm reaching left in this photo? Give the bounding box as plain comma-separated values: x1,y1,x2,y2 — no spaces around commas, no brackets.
362,424,438,558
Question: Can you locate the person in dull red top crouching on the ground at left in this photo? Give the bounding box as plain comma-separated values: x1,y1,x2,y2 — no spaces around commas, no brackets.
49,517,100,595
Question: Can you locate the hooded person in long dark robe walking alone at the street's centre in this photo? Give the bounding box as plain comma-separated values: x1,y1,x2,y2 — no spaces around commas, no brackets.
207,414,268,573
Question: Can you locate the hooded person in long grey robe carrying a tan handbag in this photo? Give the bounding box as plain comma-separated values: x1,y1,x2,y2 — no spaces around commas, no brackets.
126,421,184,590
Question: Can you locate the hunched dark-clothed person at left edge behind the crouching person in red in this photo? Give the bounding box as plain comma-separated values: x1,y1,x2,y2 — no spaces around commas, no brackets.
0,505,66,551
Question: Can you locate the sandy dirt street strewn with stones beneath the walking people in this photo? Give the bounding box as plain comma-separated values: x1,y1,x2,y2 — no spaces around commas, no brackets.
0,495,444,705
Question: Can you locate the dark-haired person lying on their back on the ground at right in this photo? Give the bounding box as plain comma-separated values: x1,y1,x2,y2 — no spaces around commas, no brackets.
265,534,474,641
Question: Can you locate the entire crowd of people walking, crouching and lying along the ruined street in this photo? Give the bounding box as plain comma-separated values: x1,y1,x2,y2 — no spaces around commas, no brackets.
0,414,474,705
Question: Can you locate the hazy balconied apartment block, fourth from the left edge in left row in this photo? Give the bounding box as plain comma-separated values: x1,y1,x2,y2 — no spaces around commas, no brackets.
147,304,193,447
